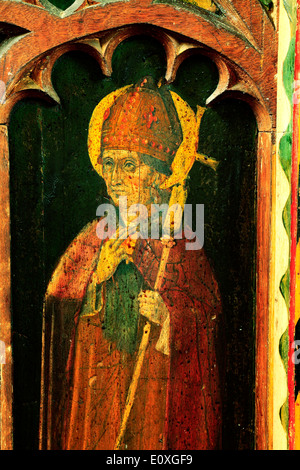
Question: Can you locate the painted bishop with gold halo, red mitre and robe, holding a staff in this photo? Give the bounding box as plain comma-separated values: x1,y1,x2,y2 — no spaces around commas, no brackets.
40,78,222,450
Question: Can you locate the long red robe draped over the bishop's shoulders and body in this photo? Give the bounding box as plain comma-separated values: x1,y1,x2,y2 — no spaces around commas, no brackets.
40,221,223,450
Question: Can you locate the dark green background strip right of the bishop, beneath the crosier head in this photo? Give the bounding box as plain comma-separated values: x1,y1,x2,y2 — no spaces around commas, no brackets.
197,100,256,449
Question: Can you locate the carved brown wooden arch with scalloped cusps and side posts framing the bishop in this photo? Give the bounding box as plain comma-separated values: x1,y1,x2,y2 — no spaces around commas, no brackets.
0,0,277,449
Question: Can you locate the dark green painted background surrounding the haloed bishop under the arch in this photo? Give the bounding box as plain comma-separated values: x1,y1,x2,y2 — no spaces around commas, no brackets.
9,37,256,449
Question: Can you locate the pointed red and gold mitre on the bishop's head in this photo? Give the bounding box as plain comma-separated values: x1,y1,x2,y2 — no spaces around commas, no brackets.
102,77,182,173
